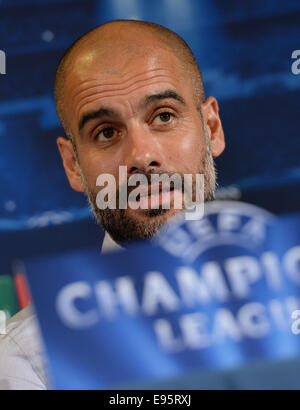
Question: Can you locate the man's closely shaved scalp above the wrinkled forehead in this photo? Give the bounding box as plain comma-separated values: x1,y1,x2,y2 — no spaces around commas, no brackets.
54,20,205,136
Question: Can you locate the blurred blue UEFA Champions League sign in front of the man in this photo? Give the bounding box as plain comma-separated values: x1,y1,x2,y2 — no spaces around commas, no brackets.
26,202,300,389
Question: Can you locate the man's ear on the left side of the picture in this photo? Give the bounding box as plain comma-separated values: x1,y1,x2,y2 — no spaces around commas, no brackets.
56,137,84,192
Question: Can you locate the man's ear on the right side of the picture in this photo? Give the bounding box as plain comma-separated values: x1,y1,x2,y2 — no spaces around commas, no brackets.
201,97,225,157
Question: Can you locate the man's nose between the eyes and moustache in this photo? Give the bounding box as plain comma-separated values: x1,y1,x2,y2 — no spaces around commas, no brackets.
125,126,164,175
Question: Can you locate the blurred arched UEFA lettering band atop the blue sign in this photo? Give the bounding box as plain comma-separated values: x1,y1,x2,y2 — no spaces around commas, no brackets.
156,201,274,264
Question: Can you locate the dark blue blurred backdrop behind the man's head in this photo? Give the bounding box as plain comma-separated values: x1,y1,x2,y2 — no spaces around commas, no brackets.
0,0,300,286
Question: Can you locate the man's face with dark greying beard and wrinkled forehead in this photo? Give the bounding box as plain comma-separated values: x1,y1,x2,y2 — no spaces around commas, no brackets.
59,42,224,242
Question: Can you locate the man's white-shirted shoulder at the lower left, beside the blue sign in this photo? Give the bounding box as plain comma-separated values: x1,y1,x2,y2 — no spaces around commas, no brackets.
0,306,47,389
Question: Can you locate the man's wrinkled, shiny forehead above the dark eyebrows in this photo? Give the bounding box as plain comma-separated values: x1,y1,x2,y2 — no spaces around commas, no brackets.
64,48,192,109
